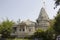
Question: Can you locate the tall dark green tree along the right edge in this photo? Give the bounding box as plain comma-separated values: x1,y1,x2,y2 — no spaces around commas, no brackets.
53,10,60,34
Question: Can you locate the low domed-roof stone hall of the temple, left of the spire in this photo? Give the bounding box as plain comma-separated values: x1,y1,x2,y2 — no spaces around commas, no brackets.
11,20,35,37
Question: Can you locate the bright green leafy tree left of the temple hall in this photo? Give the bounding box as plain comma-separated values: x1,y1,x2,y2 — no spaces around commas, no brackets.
0,19,14,38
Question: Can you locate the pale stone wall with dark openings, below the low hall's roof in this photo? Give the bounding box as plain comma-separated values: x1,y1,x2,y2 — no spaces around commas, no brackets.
11,25,35,37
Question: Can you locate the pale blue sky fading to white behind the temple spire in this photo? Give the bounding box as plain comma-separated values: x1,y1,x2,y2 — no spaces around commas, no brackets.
0,0,60,21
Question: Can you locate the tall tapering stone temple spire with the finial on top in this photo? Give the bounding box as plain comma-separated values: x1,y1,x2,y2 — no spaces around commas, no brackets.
36,1,49,30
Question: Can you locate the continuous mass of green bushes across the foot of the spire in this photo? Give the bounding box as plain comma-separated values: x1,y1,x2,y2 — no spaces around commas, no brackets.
31,27,54,40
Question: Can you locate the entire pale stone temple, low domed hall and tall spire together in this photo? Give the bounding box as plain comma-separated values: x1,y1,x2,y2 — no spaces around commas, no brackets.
11,8,49,37
